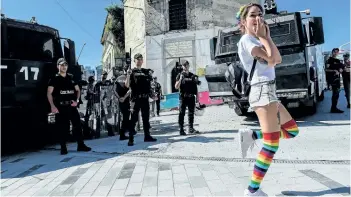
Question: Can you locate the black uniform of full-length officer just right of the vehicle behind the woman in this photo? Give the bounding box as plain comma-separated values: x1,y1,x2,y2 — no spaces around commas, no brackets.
327,57,343,111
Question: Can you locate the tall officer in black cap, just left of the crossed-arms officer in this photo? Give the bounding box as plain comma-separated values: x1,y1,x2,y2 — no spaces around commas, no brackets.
125,53,157,146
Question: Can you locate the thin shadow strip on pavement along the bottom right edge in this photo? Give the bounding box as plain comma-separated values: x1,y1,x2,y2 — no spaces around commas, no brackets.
282,187,350,196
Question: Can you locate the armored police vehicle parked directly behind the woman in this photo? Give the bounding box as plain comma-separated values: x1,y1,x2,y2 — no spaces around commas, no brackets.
205,10,325,115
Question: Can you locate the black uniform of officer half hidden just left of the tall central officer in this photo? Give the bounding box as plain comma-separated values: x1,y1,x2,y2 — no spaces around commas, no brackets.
115,75,130,138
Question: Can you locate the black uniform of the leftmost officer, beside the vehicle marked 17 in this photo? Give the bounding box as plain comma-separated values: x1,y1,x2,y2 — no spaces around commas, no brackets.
49,74,85,147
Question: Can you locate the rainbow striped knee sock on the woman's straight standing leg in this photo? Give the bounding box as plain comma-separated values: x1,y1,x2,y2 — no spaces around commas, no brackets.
248,131,280,193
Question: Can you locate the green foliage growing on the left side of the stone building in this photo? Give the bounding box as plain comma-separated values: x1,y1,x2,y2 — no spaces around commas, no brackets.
106,5,125,52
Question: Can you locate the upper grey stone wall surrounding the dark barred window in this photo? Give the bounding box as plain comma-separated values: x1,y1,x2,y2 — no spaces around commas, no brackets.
145,0,262,36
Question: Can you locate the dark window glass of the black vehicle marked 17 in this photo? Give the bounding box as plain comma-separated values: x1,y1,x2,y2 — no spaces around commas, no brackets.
1,26,60,62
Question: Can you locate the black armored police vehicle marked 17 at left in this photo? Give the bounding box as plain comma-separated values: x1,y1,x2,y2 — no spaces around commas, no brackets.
1,15,81,153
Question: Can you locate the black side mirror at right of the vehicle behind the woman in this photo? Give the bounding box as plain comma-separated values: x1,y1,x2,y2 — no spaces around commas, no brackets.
308,17,324,45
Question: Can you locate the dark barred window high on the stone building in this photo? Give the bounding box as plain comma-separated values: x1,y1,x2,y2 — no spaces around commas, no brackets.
168,0,187,31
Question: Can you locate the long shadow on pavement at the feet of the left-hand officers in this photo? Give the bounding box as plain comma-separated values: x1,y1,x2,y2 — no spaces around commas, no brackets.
1,117,237,182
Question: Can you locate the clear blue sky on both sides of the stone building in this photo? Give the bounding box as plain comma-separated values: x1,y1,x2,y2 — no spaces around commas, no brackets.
1,0,350,67
